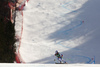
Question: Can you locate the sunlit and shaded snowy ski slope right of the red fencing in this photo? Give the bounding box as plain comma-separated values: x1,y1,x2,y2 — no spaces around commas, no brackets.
16,0,100,64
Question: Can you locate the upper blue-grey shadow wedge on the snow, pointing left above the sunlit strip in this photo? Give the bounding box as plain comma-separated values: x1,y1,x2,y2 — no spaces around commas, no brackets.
47,0,100,41
